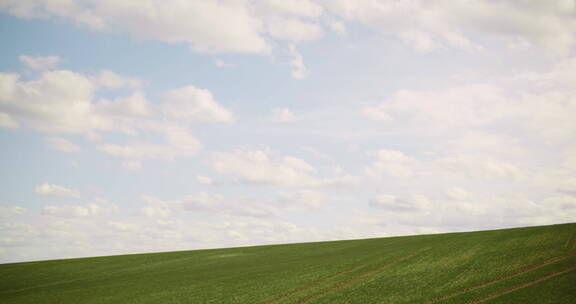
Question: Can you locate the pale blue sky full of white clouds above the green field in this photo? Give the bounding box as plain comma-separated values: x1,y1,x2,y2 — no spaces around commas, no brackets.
0,0,576,263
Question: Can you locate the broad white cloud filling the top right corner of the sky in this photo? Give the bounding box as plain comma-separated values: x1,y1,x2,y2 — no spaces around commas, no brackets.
320,0,576,55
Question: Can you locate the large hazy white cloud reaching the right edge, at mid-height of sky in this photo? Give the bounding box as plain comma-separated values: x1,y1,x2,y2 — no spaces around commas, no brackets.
363,58,576,142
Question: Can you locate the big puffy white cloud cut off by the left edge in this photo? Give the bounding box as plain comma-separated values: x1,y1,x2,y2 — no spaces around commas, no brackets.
0,70,147,134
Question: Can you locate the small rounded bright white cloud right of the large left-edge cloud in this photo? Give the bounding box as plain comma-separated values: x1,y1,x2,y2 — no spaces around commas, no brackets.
160,86,234,122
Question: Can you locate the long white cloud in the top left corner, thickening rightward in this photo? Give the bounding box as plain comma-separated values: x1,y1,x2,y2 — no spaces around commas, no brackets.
0,0,270,53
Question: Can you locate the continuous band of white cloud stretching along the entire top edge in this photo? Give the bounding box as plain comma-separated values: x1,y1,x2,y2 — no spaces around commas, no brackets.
0,0,576,60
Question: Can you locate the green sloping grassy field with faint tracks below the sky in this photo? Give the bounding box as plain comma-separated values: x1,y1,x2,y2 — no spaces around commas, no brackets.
0,224,576,304
